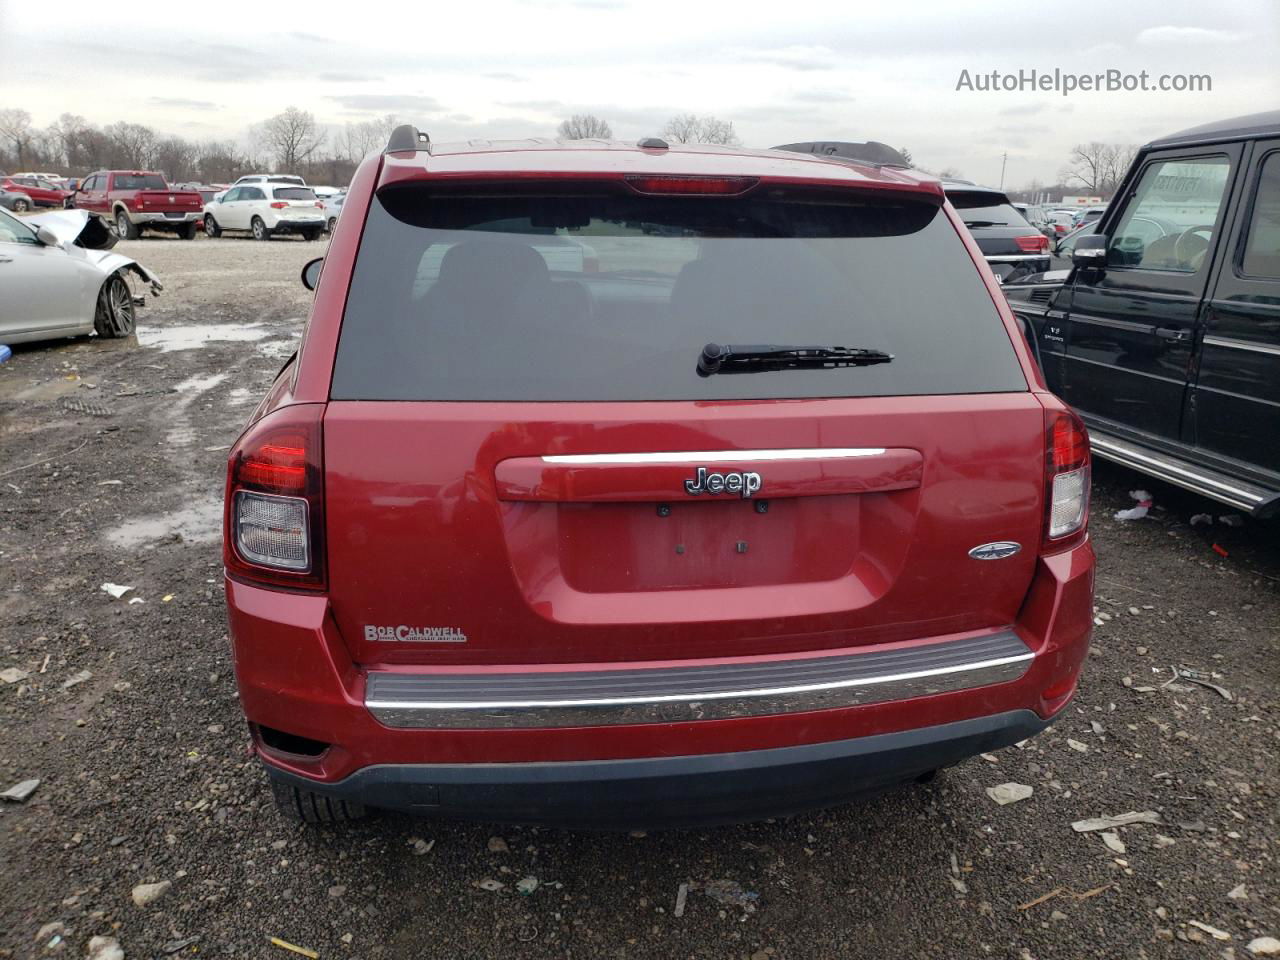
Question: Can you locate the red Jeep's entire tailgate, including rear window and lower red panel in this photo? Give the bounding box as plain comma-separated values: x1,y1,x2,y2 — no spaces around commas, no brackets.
324,186,1044,666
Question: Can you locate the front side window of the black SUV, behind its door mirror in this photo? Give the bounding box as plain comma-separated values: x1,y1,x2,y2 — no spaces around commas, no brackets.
1107,156,1231,273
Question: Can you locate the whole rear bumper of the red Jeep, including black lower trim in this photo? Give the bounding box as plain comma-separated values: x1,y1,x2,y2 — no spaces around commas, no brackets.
227,540,1093,823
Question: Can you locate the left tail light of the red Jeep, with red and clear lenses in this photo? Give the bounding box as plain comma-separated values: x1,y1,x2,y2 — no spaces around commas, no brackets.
223,403,325,590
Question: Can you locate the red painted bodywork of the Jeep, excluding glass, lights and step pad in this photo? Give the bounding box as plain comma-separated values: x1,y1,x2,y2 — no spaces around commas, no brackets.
227,143,1093,803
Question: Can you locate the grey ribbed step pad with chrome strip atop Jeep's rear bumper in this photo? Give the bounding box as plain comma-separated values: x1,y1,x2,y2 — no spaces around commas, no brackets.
365,630,1034,730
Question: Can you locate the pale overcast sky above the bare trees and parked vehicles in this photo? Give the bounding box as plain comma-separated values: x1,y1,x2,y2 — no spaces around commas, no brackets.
0,0,1280,187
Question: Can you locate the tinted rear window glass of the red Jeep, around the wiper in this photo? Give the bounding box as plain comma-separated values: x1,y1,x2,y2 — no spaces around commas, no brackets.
332,186,1027,401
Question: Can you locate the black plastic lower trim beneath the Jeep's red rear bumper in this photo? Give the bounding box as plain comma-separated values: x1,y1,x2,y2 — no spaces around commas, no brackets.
268,710,1050,829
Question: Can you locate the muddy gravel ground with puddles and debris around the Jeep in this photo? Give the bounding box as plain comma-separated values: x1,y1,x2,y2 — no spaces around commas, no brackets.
0,238,1280,960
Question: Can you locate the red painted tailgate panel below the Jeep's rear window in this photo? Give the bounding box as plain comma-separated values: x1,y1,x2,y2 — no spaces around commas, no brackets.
324,393,1044,663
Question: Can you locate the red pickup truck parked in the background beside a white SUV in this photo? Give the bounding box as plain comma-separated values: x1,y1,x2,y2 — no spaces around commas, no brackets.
73,170,205,239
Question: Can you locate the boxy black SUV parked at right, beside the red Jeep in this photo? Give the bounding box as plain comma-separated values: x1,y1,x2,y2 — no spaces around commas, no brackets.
1005,111,1280,517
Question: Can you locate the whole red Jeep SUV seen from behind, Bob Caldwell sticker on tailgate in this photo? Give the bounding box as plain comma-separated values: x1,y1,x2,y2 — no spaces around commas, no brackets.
224,127,1093,827
